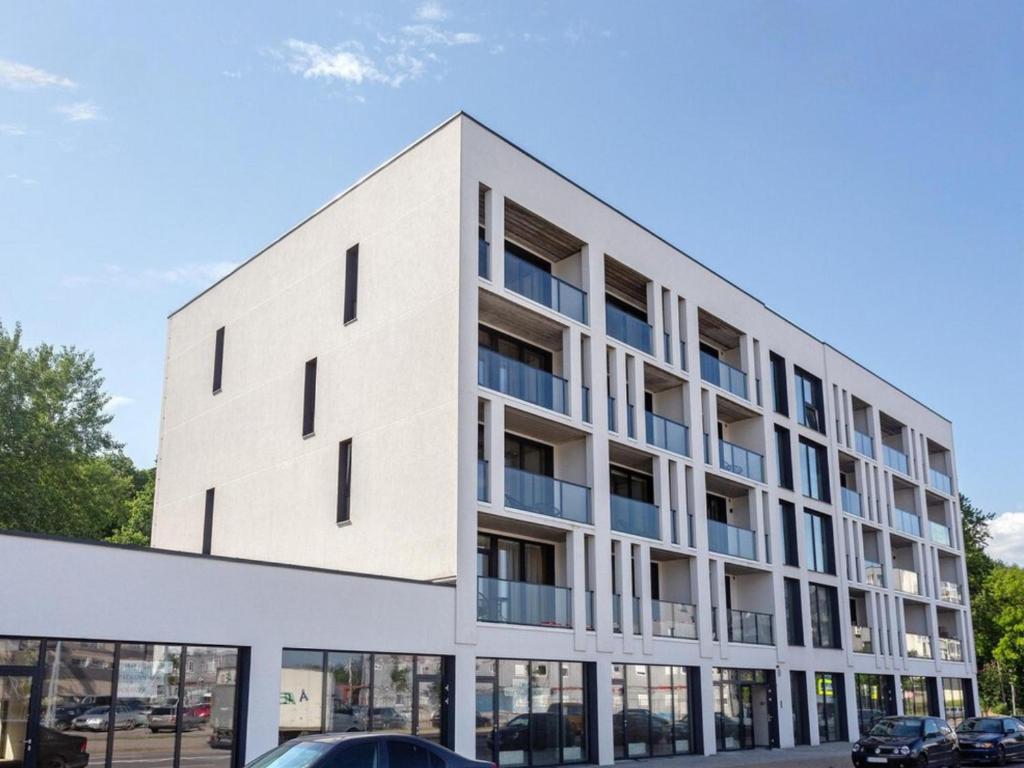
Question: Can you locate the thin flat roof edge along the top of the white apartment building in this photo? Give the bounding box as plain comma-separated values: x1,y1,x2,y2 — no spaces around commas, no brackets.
168,110,952,426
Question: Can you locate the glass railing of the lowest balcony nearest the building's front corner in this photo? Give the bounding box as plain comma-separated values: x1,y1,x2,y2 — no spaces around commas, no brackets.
476,577,572,627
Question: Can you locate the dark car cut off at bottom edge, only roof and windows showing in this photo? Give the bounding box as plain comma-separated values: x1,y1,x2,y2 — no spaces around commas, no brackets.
246,733,494,768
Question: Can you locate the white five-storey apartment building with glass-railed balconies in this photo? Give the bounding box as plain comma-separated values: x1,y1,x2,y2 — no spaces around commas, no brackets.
0,114,977,766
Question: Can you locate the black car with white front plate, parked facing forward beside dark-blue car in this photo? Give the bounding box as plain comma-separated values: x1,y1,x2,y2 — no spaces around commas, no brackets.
850,717,961,768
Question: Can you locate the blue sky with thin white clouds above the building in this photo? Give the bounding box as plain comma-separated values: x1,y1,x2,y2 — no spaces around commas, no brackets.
0,0,1024,559
